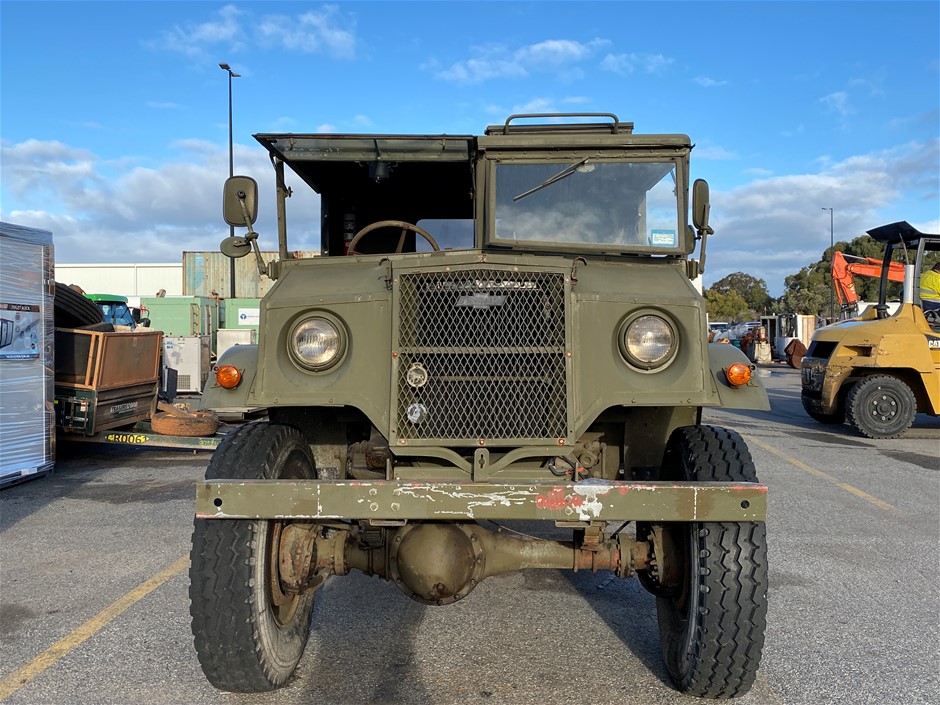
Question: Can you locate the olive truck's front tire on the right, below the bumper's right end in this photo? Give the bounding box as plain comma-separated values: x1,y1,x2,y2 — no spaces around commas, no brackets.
656,426,767,698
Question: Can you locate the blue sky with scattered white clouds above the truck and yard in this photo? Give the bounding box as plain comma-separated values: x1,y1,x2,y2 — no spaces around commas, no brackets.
0,0,940,296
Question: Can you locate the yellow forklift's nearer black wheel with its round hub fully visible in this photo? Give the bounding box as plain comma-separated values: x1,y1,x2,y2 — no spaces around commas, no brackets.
845,375,917,438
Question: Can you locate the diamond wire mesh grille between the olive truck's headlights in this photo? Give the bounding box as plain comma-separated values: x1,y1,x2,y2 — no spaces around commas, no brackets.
397,269,568,443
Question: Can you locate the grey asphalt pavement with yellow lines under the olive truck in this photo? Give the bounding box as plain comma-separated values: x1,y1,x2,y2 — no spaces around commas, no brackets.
0,365,940,705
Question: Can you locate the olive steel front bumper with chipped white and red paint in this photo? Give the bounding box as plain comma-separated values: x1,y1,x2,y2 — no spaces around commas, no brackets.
196,480,767,524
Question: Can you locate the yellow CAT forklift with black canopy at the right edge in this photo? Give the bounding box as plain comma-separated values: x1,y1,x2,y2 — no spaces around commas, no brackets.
801,221,940,438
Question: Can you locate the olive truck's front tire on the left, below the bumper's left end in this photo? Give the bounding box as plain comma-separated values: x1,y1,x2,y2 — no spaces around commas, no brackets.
189,423,315,693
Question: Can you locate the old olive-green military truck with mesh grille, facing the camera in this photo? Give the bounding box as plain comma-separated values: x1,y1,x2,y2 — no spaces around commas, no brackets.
190,113,769,697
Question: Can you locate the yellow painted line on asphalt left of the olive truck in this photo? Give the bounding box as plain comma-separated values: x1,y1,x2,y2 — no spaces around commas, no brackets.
0,555,189,700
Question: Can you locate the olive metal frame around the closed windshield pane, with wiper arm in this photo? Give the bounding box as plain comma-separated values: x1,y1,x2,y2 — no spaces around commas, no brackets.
483,150,690,257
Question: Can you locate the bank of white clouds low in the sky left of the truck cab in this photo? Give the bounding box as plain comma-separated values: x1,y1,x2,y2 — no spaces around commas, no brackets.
0,140,319,262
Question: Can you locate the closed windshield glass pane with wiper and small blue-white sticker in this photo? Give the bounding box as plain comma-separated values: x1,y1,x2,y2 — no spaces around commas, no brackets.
494,158,680,251
